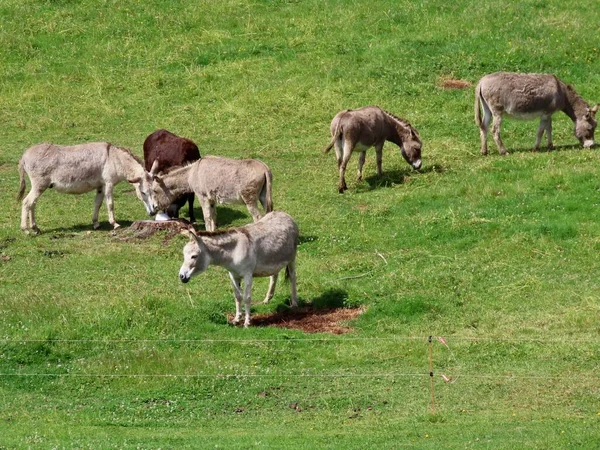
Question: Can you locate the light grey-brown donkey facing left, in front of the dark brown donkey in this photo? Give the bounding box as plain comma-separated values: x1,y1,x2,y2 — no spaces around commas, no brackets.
150,156,273,231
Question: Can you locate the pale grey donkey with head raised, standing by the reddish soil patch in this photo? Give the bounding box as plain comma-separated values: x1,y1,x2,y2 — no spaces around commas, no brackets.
179,211,298,327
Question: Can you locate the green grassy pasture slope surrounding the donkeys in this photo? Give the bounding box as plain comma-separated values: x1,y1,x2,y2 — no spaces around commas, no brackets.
0,0,600,449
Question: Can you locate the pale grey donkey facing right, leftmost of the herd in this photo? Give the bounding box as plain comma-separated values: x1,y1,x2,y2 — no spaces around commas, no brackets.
17,142,156,233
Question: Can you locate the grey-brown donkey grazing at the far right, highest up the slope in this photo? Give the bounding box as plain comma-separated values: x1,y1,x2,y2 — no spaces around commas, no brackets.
475,72,598,155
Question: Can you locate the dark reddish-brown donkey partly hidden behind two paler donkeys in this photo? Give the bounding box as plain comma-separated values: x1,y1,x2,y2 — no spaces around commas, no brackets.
144,130,200,222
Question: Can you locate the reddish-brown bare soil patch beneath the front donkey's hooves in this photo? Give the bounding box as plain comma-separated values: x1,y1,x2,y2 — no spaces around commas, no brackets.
252,306,364,334
